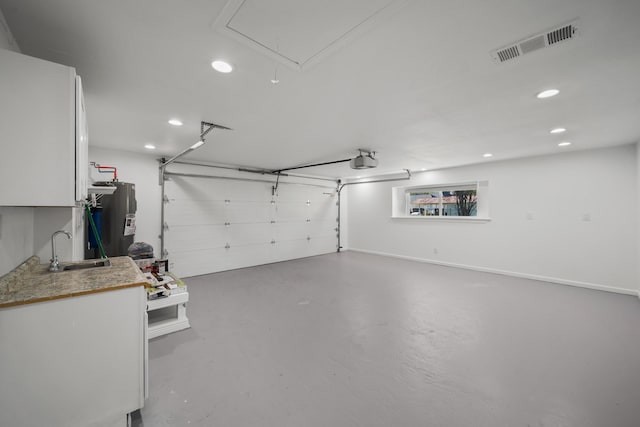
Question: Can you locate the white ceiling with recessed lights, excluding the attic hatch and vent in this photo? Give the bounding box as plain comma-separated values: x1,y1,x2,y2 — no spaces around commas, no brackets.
0,0,640,177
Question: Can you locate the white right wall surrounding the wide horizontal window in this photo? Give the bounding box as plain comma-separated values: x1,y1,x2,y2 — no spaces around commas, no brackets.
345,145,638,294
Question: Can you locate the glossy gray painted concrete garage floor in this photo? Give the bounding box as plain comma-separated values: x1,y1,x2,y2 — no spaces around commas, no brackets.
142,252,640,427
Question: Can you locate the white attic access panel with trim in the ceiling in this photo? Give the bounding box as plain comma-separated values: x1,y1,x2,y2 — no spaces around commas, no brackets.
212,0,407,71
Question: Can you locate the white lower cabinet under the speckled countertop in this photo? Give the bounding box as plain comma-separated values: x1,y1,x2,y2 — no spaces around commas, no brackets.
0,286,147,427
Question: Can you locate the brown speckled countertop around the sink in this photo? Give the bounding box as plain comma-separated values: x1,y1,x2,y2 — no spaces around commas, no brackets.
0,256,146,308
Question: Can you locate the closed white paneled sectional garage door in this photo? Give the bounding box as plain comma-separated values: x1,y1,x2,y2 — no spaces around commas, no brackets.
165,175,337,277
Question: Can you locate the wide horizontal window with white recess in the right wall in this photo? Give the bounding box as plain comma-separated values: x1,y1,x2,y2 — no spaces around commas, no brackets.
393,181,488,220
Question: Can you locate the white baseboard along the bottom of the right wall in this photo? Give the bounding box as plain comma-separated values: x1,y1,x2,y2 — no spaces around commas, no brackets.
343,248,640,297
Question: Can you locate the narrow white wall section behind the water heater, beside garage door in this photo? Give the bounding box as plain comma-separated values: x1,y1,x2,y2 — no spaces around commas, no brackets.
88,145,161,256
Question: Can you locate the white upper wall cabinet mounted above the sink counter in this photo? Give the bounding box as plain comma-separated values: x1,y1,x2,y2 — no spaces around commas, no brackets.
0,49,88,206
